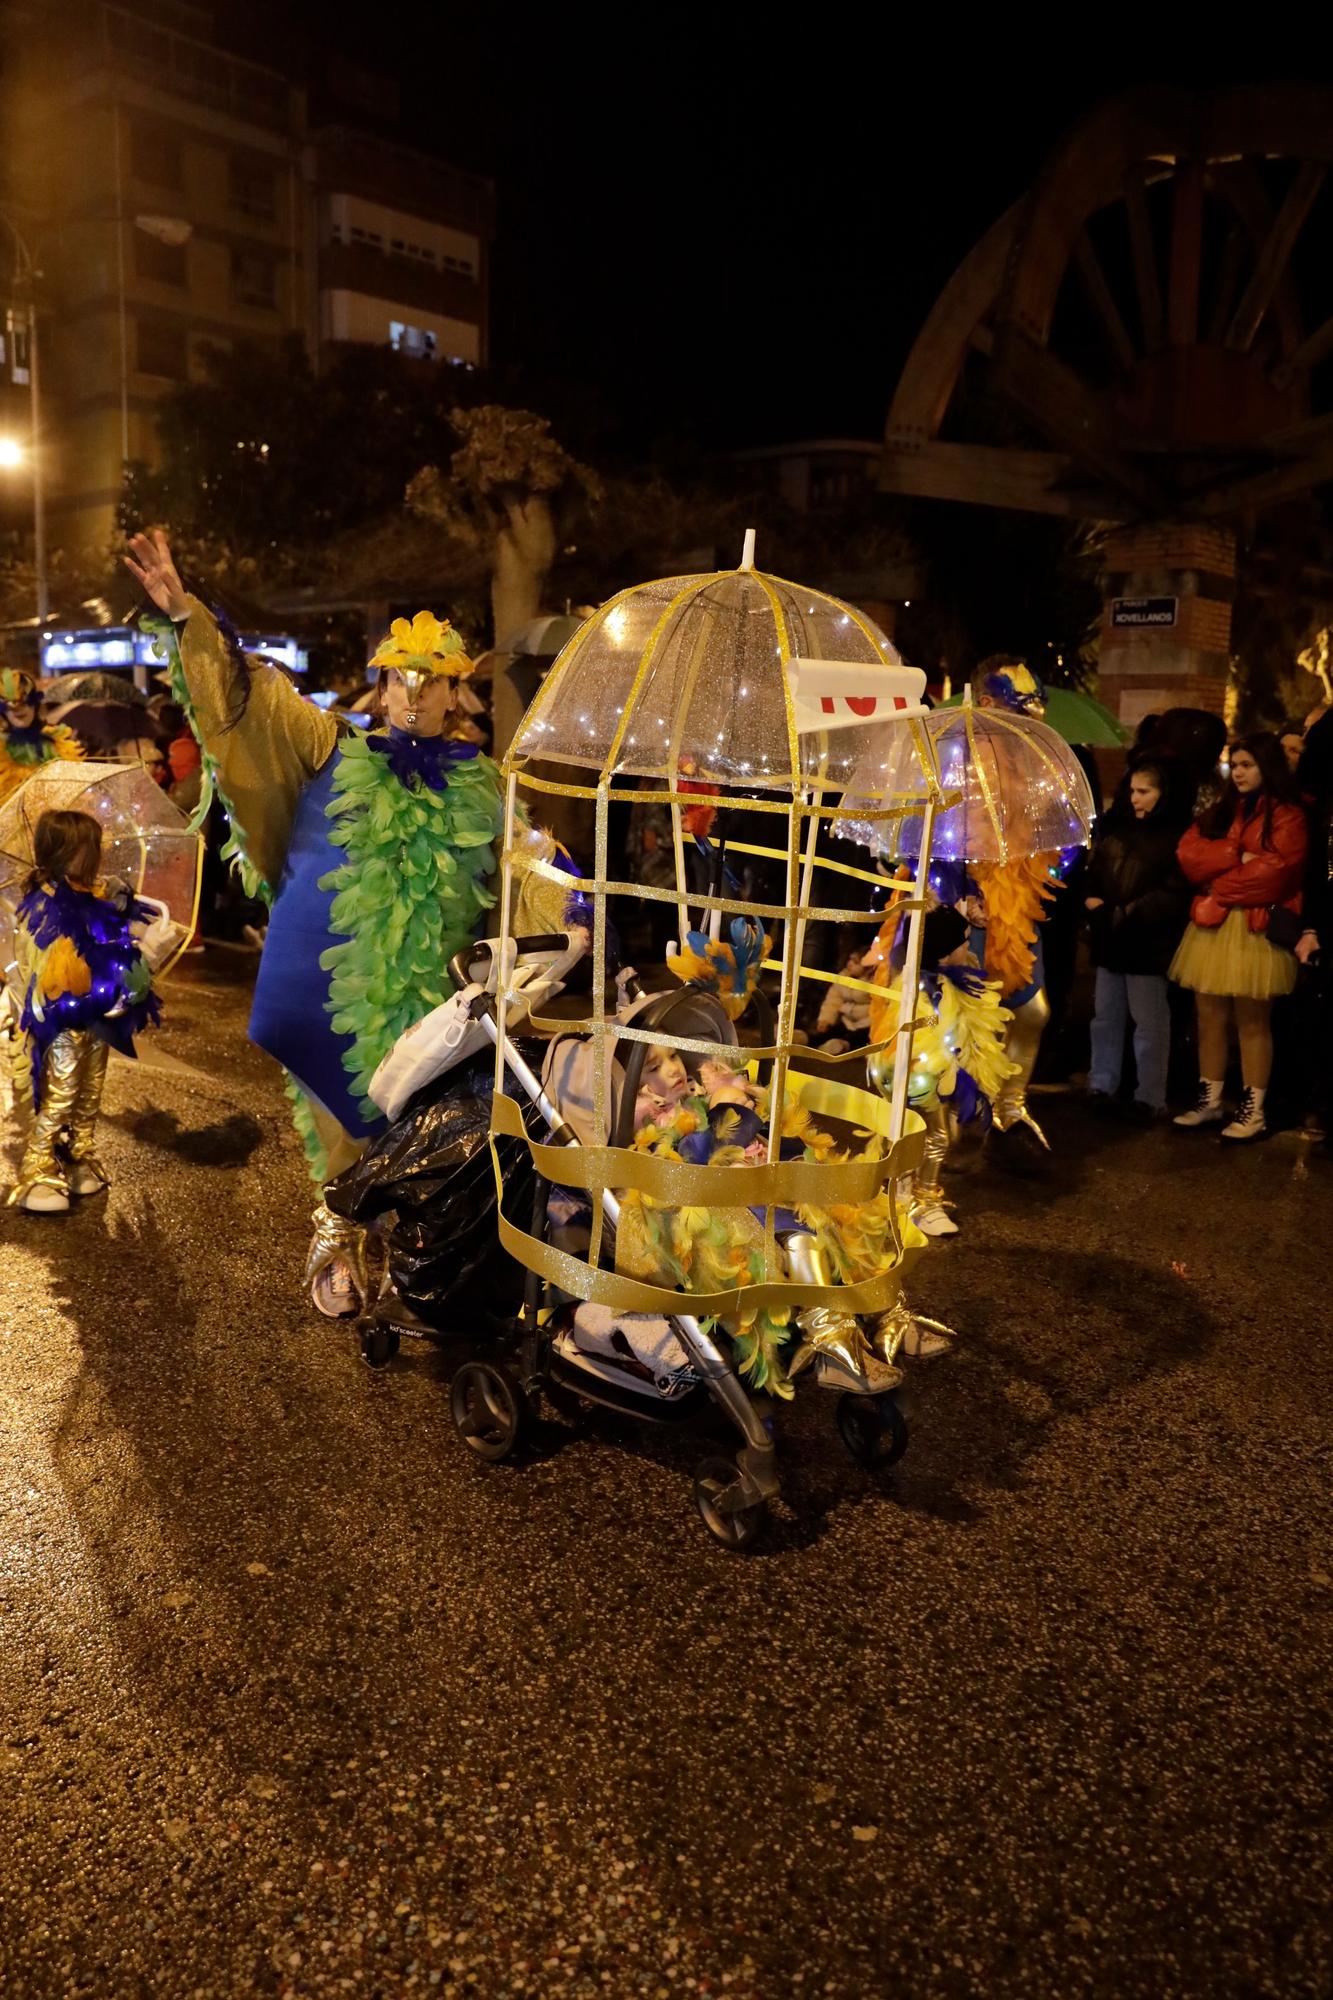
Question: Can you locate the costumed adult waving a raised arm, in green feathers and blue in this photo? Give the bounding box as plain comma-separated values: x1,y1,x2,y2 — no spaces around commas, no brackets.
124,532,572,1318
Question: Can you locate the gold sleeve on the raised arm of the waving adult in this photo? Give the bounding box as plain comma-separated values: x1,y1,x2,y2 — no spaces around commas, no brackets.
180,598,338,888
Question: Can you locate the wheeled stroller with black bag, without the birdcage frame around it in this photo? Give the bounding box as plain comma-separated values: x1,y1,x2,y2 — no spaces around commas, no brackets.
338,936,921,1550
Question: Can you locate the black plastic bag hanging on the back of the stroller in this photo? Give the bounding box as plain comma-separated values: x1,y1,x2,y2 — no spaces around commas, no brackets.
324,1054,540,1328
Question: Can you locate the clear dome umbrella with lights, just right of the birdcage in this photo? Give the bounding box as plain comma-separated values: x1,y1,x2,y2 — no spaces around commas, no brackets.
843,698,1093,862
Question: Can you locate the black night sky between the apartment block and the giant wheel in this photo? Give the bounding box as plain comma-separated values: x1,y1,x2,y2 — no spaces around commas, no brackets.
228,11,1315,448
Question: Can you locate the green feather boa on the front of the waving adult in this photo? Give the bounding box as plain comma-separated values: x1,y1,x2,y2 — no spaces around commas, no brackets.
320,736,504,1098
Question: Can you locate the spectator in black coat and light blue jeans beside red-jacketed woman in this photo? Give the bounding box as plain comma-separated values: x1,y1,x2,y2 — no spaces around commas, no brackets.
1083,756,1191,1122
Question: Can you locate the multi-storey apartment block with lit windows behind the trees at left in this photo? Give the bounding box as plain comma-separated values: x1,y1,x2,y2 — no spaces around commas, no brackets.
0,0,492,546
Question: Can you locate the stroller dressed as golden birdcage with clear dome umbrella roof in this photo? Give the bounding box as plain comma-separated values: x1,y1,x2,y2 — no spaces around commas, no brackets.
326,548,945,1550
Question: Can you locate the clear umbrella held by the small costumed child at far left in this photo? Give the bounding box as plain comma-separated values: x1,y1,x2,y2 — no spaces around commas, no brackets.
0,758,204,964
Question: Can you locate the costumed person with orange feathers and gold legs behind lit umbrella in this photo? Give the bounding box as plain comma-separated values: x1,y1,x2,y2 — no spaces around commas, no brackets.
969,656,1061,1156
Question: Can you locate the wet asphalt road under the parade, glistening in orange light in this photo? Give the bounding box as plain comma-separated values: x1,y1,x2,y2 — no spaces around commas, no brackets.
0,954,1333,2000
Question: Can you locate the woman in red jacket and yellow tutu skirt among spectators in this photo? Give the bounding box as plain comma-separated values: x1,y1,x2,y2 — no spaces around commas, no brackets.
1171,734,1309,1142
